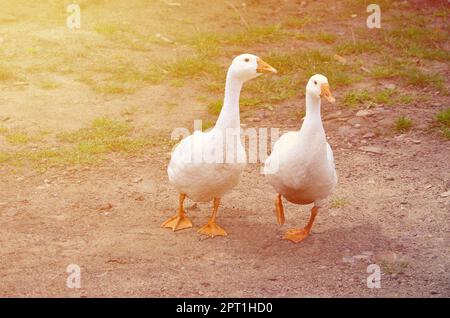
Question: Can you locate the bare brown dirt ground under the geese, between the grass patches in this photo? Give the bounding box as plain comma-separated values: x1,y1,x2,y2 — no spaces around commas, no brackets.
0,1,450,297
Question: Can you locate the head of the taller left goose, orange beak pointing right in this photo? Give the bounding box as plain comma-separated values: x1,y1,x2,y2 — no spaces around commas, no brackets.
228,54,277,82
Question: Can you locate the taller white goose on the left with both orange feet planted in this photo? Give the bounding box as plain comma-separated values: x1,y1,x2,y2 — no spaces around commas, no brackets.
161,54,276,237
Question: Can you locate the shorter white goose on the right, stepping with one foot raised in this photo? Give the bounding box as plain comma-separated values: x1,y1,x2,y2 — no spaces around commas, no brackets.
264,74,337,243
